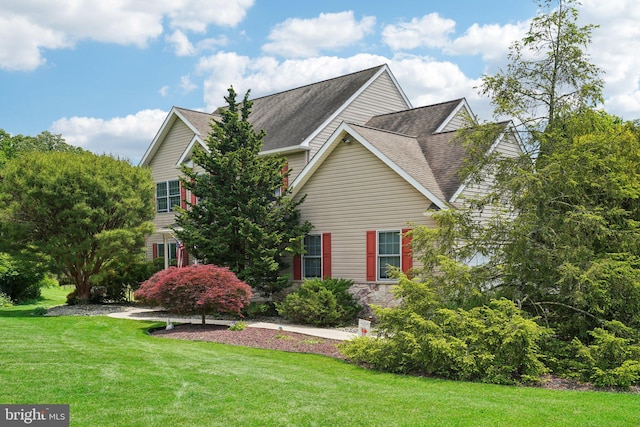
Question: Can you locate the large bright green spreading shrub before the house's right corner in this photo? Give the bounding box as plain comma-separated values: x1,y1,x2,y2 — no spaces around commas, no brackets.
341,276,549,384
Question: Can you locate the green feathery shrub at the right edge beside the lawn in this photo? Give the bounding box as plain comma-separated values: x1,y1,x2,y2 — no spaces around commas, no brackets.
572,320,640,388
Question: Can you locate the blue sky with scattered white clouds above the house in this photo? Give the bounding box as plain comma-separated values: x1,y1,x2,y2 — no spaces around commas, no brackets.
0,0,640,164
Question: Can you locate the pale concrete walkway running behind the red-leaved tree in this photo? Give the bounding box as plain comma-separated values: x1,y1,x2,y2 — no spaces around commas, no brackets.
108,307,357,341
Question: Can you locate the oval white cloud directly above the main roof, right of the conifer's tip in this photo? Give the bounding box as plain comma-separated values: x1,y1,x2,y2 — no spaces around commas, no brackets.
262,11,376,58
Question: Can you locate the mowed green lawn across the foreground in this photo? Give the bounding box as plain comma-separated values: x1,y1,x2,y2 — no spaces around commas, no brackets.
0,290,640,427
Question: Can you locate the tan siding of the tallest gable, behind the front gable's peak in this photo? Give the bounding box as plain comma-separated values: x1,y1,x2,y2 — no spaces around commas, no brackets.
309,73,409,159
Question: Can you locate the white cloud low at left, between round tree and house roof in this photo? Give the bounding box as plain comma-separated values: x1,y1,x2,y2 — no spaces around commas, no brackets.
51,110,167,164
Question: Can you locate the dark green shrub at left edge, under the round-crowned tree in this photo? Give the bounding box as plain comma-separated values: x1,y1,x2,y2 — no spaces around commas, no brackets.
0,252,45,304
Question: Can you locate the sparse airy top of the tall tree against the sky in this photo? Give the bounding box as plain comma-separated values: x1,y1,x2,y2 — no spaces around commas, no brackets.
480,0,603,154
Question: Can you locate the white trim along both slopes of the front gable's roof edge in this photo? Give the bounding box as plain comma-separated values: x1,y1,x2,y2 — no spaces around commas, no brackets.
290,122,449,210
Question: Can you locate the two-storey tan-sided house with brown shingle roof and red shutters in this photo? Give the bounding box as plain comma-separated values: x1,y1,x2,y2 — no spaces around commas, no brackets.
140,65,518,304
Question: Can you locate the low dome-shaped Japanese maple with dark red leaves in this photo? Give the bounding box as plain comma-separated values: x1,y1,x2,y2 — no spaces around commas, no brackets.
134,264,251,324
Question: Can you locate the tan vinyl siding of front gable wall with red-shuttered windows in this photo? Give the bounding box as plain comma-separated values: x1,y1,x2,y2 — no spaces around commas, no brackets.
300,143,433,283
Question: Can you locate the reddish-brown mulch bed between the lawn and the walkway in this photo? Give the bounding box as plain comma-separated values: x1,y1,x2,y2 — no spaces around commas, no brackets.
151,324,344,359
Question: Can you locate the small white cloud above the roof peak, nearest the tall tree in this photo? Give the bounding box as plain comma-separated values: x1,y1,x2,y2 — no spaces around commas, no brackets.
382,13,456,50
